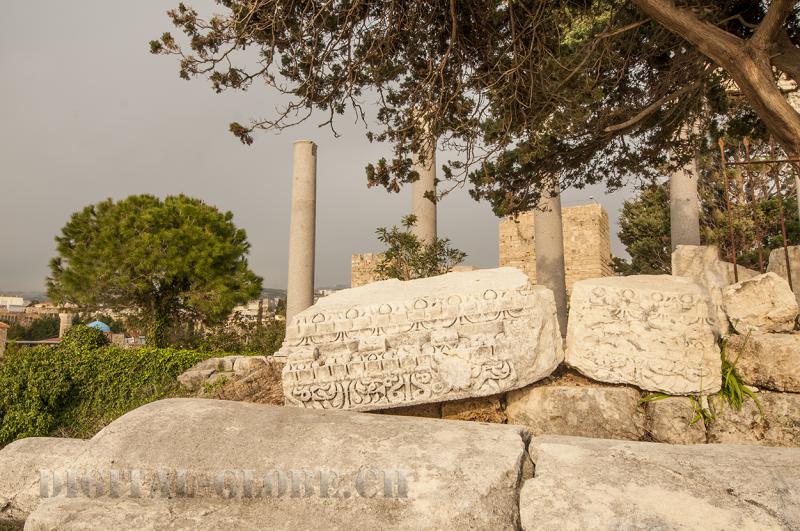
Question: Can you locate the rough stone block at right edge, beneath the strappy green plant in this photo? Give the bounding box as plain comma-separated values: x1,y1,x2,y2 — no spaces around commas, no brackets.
708,391,800,447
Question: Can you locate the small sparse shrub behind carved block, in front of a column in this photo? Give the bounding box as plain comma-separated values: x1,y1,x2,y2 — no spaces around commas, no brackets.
375,215,467,280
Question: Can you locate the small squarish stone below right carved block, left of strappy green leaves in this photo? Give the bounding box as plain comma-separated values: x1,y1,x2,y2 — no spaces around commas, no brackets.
646,396,706,444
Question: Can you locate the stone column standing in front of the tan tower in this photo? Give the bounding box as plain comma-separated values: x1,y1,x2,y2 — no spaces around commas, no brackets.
533,181,567,337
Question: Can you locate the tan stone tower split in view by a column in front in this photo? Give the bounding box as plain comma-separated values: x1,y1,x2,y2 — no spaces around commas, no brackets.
500,203,614,291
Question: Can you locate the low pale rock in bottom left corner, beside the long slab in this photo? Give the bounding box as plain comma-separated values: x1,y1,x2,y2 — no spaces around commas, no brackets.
0,437,86,529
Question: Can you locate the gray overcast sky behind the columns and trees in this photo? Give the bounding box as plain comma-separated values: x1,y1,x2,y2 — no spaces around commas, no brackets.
0,0,629,291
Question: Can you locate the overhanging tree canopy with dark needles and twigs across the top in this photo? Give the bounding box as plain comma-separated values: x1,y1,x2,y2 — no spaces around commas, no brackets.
150,0,800,214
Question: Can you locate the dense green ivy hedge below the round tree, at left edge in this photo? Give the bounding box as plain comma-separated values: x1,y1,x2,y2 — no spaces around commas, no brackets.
0,326,212,447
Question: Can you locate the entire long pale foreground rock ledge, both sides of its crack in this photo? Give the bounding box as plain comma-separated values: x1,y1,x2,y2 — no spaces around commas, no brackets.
0,399,800,531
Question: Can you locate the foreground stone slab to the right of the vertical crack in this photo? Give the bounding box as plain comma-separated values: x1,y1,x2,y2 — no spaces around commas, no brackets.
520,436,800,530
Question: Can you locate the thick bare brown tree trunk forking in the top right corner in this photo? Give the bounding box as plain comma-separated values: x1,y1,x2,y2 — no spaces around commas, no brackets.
633,0,800,156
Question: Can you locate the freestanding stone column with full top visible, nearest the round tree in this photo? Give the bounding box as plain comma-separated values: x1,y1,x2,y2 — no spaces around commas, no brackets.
286,140,317,326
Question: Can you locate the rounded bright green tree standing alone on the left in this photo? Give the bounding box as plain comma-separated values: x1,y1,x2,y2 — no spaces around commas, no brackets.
48,195,261,346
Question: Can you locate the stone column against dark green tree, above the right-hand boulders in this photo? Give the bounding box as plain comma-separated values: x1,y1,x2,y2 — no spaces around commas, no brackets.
669,158,700,251
